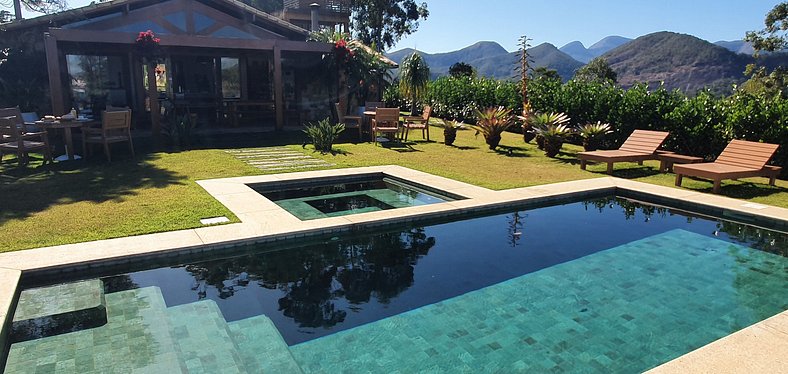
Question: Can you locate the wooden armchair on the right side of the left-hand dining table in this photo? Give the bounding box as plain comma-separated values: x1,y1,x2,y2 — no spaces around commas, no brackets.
82,110,134,162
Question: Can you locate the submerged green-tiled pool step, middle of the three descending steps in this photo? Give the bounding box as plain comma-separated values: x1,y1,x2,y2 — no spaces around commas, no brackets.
167,300,249,373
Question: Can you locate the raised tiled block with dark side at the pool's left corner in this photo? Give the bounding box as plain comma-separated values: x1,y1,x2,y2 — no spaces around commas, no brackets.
10,279,107,342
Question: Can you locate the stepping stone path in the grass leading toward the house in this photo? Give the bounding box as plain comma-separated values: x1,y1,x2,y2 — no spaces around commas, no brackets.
226,147,334,171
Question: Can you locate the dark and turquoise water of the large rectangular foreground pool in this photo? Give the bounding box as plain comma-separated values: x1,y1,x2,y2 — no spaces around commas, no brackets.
6,198,788,372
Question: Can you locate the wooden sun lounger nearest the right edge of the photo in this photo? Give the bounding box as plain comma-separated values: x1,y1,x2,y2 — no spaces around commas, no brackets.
673,140,780,193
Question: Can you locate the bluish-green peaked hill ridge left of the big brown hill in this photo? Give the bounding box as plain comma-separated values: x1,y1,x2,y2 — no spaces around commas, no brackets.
386,42,583,80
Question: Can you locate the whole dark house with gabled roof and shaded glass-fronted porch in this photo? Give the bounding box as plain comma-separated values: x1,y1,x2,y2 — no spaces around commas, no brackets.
0,0,350,131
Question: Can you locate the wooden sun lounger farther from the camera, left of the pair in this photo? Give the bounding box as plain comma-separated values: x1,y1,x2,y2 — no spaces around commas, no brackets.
577,130,668,174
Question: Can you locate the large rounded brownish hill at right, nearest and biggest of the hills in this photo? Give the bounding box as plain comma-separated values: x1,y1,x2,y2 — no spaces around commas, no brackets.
604,31,751,92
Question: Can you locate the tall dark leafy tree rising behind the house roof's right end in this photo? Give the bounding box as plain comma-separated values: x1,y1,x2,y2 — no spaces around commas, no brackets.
350,0,430,51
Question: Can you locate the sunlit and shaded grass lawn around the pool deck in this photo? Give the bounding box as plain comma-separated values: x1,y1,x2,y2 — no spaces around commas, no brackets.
0,128,788,251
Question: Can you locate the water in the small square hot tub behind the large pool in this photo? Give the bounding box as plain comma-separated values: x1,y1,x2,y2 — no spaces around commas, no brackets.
253,176,455,221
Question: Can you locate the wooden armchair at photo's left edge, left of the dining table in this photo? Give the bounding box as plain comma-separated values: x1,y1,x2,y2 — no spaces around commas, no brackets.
0,116,52,166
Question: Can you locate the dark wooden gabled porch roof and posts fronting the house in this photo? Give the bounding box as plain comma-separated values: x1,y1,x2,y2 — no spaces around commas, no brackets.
6,0,332,132
